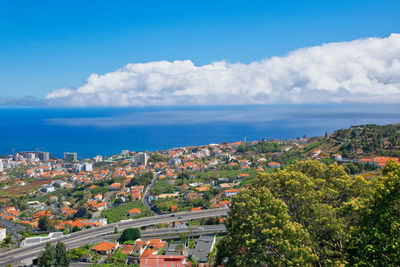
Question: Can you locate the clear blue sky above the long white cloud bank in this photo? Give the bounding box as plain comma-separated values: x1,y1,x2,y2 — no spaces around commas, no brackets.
0,0,400,103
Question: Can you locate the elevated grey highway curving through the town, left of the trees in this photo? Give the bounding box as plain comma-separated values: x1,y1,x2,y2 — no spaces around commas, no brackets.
0,208,229,266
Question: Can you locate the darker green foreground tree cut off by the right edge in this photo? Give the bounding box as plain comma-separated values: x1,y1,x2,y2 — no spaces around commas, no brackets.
345,161,400,266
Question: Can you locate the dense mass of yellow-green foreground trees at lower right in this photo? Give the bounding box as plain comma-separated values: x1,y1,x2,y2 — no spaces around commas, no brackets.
216,160,400,266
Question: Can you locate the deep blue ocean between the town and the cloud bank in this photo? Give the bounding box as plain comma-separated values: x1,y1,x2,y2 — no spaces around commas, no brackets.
0,104,400,158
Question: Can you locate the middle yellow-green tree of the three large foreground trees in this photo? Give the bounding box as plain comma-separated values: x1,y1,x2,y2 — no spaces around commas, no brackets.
244,160,371,266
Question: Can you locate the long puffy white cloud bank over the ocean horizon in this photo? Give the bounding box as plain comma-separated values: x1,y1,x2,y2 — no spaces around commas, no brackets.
45,34,400,106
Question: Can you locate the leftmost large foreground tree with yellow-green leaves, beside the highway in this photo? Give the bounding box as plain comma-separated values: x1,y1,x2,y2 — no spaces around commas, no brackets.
216,187,318,266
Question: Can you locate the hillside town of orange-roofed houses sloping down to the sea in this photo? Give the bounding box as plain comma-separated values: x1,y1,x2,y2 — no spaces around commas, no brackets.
0,124,399,266
